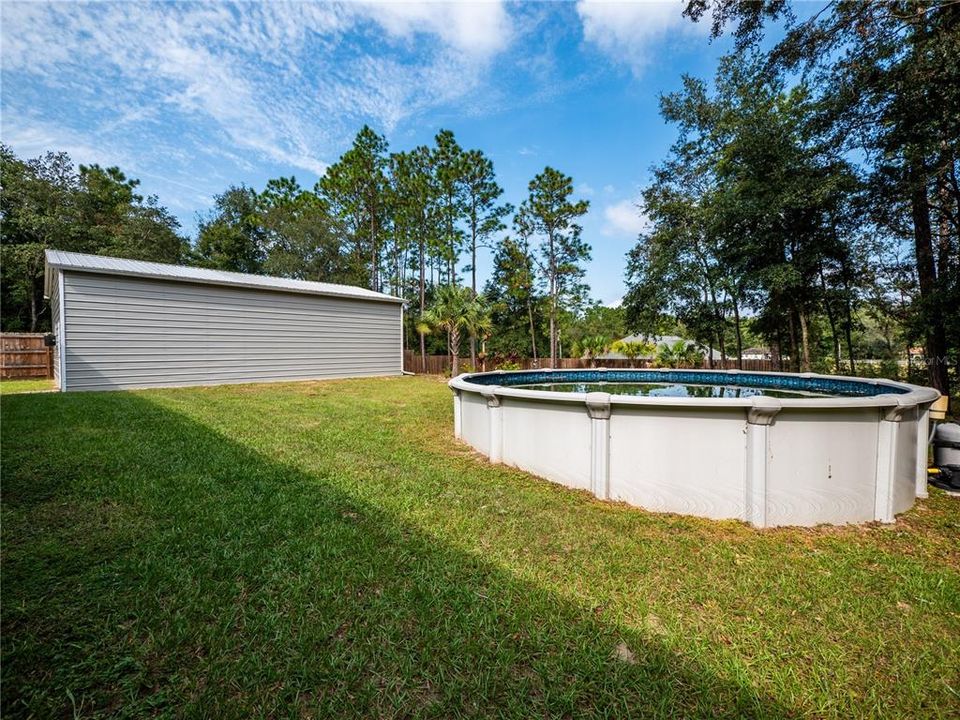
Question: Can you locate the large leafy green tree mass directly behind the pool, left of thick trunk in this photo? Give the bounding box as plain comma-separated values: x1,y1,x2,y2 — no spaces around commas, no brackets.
625,57,864,371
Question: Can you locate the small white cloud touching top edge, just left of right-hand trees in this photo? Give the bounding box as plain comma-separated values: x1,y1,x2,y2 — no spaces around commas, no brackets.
577,0,709,75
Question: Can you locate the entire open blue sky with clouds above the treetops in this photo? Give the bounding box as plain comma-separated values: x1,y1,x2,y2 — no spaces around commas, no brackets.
0,1,772,303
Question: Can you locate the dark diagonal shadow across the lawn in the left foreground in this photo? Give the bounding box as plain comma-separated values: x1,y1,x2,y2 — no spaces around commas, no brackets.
2,393,791,718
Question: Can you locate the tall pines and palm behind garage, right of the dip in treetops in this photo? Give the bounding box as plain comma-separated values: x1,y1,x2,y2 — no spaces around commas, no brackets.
176,126,590,366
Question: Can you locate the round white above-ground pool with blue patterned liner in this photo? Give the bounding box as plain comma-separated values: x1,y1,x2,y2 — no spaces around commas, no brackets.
450,368,939,527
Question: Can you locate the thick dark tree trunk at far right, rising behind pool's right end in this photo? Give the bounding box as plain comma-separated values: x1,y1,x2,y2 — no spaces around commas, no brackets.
910,161,950,395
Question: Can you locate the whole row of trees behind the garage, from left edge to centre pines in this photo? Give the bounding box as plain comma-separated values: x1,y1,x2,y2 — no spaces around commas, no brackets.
0,126,590,372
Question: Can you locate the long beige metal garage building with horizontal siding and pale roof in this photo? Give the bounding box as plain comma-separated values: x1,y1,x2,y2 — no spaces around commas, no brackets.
45,250,403,390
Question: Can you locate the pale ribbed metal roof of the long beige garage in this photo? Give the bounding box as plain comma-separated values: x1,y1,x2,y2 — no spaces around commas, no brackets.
46,250,403,303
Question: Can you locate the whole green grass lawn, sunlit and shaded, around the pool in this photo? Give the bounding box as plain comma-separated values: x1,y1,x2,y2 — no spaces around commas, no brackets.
0,377,960,718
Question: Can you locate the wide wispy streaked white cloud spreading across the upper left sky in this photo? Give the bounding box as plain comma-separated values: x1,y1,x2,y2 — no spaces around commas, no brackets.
0,1,513,174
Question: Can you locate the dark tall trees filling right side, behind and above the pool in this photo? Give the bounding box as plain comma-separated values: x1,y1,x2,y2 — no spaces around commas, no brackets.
624,0,960,393
